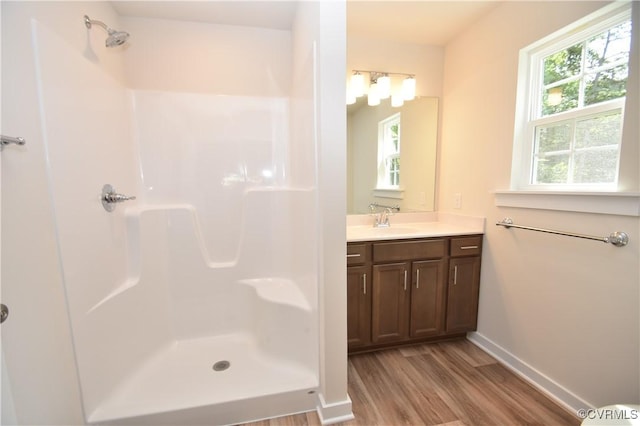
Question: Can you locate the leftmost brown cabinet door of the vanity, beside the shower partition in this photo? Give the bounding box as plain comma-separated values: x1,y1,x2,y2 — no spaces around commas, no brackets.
347,266,371,349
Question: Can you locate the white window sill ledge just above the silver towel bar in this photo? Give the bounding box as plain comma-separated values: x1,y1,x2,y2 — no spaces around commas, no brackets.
495,191,640,217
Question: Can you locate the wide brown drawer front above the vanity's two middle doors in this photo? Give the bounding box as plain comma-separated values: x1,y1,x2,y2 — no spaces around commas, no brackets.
373,239,447,263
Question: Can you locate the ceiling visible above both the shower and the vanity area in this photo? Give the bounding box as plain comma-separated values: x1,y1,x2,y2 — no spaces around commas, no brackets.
112,0,499,46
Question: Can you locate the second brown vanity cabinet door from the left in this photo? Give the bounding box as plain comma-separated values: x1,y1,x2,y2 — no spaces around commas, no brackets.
371,262,411,343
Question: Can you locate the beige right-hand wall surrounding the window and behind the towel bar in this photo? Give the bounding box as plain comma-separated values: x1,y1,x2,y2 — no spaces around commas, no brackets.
438,1,640,408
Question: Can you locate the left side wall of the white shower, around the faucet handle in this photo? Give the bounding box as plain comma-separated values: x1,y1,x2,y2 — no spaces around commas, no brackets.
33,21,170,411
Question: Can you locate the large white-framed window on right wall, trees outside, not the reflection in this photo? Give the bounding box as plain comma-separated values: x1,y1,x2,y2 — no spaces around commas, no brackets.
512,3,631,191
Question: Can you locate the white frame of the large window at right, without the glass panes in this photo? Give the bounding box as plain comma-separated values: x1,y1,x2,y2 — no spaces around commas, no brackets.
511,2,635,192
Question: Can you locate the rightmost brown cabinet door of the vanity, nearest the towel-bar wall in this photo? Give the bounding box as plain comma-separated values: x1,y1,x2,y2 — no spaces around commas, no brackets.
446,257,480,333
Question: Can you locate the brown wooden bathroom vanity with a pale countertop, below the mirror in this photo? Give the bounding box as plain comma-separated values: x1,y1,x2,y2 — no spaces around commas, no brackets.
347,215,484,353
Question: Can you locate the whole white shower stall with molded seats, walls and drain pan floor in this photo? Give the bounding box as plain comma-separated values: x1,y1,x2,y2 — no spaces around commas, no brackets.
10,2,340,425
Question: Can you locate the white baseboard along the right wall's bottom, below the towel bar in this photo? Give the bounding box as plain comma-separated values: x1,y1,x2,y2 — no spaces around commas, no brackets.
467,332,596,415
